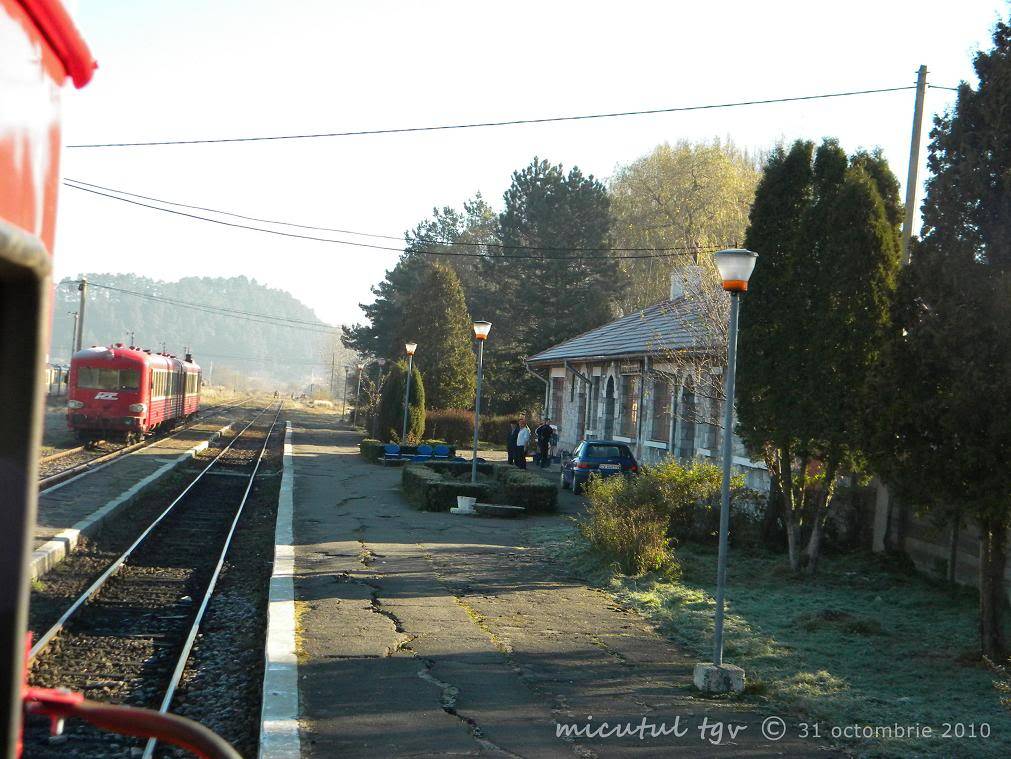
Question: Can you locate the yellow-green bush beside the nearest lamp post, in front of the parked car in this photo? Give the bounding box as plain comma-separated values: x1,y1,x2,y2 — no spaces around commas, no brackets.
579,459,744,574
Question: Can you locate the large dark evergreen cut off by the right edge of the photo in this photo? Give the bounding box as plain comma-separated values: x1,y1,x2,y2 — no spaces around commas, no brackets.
871,16,1011,661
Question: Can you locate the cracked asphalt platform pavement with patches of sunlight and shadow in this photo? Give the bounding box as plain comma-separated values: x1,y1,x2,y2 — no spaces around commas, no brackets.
292,413,832,757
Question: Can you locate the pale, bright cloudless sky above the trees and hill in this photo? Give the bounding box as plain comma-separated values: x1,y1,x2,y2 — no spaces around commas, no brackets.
56,0,1011,323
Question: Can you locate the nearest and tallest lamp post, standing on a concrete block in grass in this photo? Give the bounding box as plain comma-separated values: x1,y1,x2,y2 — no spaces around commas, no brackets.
695,249,758,692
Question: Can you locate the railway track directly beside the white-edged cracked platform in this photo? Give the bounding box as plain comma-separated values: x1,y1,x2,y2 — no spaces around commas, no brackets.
26,404,281,759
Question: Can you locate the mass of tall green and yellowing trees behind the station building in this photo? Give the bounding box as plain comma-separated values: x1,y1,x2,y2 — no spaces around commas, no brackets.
344,140,759,413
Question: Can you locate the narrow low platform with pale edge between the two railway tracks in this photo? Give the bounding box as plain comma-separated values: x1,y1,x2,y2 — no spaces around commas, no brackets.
31,414,228,579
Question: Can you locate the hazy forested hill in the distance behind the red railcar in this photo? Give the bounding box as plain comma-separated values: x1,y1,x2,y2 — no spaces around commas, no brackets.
50,273,353,387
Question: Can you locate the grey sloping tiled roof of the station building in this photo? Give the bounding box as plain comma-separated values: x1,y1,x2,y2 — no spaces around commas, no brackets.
527,298,716,364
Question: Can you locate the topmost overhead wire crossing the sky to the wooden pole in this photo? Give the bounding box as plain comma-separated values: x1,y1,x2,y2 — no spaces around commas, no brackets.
67,85,915,148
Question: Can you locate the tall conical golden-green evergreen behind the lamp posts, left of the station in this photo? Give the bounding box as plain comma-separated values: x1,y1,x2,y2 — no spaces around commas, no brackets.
400,263,476,408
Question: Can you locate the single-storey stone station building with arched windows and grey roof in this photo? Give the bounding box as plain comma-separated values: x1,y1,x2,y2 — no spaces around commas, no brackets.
527,267,769,491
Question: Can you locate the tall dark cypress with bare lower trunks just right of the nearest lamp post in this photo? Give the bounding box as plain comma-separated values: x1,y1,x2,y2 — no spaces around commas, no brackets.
738,139,899,573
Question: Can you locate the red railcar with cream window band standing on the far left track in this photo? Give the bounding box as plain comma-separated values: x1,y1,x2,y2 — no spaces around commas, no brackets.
67,343,200,441
